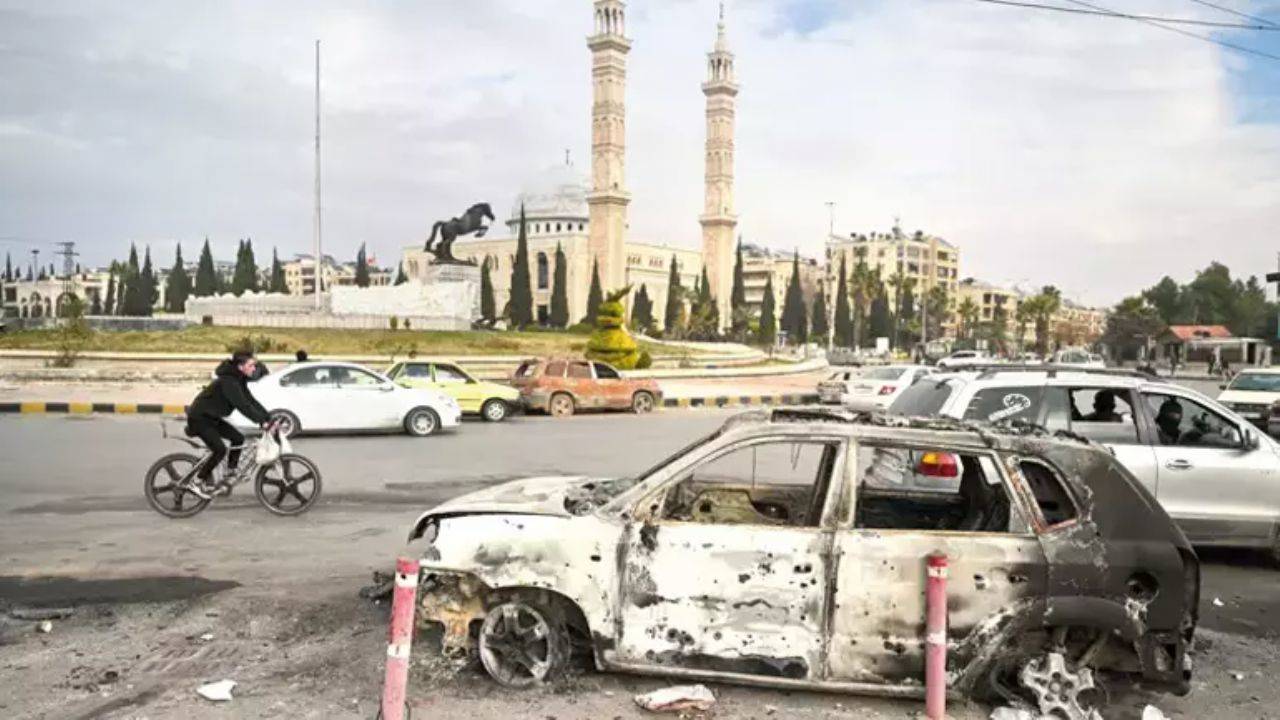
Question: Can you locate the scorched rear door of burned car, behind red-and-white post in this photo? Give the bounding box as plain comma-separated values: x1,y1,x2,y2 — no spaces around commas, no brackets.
827,445,1046,685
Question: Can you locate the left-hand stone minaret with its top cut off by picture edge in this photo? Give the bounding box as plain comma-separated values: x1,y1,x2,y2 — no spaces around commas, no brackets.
586,0,631,291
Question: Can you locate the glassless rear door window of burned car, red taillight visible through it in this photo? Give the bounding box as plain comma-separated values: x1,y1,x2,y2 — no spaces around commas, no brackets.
854,446,1025,533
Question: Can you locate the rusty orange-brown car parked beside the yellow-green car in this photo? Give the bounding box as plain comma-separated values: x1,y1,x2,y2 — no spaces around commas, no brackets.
511,357,662,416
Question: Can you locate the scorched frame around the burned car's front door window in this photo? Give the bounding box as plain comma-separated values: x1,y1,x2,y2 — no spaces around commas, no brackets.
626,432,852,533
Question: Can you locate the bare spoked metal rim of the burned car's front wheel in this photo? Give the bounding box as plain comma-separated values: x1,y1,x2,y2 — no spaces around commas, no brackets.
480,602,553,685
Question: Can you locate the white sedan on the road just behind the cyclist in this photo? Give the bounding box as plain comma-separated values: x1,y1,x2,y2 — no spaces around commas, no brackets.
230,363,462,436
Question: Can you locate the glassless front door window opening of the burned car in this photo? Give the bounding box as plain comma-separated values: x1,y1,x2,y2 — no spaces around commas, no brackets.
660,441,840,527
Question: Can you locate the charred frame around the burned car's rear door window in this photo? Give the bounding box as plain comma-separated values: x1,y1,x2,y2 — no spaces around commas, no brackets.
836,438,1039,539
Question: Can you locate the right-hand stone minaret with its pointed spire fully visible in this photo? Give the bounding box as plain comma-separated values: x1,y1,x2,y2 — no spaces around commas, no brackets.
699,1,737,329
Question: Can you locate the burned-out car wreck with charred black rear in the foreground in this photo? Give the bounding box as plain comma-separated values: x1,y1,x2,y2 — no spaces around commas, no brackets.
410,407,1199,717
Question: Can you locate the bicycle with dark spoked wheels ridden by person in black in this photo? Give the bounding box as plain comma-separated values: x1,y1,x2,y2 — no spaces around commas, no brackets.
142,423,321,518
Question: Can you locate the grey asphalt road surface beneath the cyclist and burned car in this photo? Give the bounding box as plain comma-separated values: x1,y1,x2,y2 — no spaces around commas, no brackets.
0,397,1280,720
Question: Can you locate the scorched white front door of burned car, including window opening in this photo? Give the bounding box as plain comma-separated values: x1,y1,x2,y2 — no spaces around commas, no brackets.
616,437,845,680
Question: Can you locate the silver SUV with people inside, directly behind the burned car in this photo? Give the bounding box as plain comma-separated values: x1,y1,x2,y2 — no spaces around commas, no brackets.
890,366,1280,561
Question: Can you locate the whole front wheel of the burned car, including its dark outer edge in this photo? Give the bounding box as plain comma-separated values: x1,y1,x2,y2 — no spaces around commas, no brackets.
476,597,573,688
